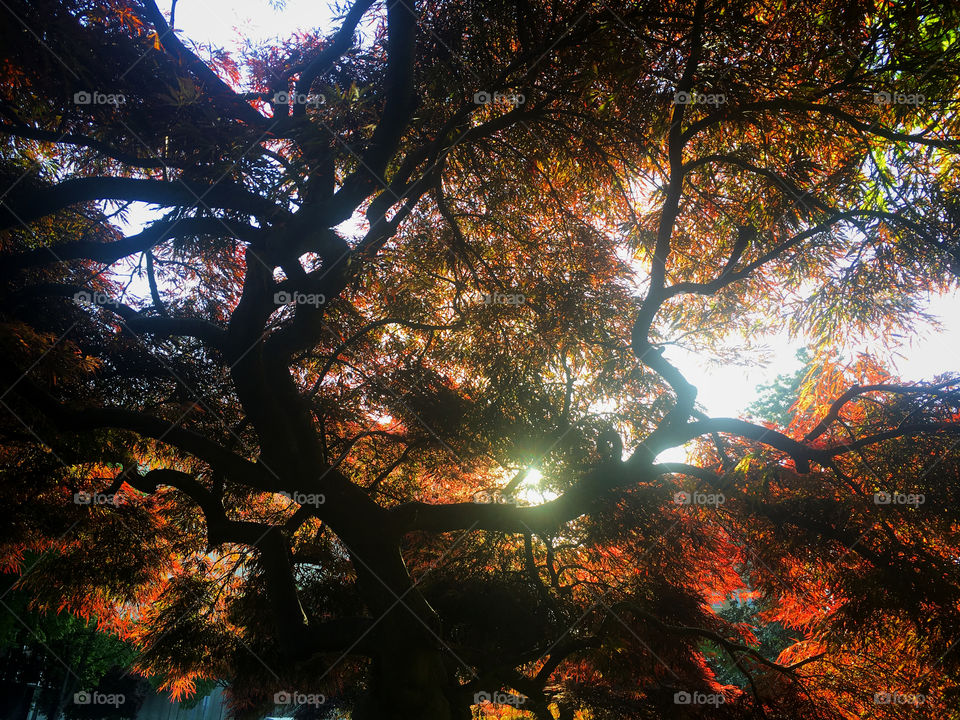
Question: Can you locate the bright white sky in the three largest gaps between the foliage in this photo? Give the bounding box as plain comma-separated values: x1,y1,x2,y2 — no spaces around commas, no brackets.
146,0,960,417
